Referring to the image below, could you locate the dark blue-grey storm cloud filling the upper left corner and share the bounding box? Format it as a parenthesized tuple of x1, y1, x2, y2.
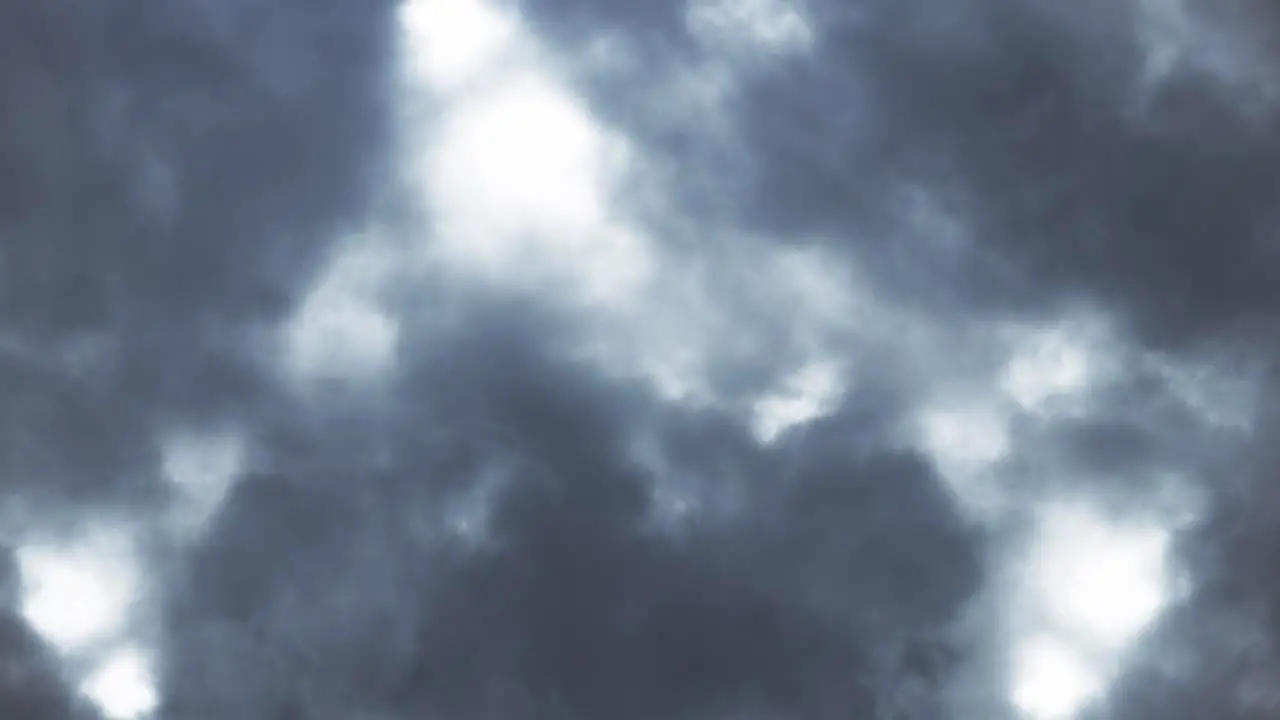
(0, 0, 390, 504)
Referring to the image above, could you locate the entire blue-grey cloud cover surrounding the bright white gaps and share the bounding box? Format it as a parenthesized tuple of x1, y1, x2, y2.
(0, 0, 1280, 719)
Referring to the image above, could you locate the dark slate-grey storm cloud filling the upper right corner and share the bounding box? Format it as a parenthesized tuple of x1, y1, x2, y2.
(522, 0, 1280, 346)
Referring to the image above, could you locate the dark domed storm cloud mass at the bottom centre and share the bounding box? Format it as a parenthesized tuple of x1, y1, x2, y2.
(166, 319, 979, 717)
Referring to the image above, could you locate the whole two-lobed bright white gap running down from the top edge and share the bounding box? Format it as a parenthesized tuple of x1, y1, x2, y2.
(391, 0, 652, 311)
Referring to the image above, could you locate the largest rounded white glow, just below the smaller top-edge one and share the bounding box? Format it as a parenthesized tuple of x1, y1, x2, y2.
(422, 70, 650, 304)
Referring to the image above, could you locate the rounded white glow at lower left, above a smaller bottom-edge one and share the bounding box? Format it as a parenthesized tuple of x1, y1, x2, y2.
(17, 529, 141, 653)
